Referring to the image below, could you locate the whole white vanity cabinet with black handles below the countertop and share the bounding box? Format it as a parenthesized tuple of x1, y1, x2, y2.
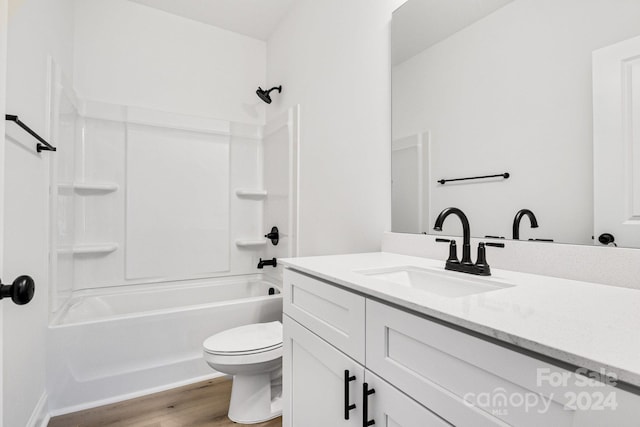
(283, 269, 640, 427)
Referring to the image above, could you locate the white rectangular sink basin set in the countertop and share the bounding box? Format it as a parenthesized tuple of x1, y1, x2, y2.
(356, 266, 515, 298)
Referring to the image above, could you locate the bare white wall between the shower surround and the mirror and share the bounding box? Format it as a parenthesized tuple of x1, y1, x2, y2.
(267, 0, 402, 256)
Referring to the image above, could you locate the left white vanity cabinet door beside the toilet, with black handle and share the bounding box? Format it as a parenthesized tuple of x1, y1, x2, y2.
(282, 315, 364, 427)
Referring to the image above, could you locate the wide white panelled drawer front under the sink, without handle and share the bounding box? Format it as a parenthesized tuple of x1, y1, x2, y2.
(366, 300, 638, 427)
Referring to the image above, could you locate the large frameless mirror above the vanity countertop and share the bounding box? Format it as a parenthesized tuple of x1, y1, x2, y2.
(391, 0, 640, 247)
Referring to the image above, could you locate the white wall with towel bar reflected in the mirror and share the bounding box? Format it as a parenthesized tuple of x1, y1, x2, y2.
(393, 0, 640, 244)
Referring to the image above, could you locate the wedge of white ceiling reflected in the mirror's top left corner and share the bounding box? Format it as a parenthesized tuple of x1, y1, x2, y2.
(391, 0, 513, 65)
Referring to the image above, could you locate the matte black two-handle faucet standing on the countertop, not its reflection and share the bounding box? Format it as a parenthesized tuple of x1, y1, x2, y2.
(433, 208, 504, 276)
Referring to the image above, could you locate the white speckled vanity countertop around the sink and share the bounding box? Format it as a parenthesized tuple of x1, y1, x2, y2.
(278, 252, 640, 387)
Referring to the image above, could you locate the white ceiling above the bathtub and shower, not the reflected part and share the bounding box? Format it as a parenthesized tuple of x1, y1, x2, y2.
(131, 0, 295, 40)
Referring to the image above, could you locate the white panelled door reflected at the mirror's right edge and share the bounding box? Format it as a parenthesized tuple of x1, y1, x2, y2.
(593, 33, 640, 247)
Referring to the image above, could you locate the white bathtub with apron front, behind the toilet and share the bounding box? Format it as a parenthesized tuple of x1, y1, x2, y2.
(47, 275, 282, 415)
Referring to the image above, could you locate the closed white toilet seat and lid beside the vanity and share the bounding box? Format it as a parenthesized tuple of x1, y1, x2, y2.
(202, 322, 282, 365)
